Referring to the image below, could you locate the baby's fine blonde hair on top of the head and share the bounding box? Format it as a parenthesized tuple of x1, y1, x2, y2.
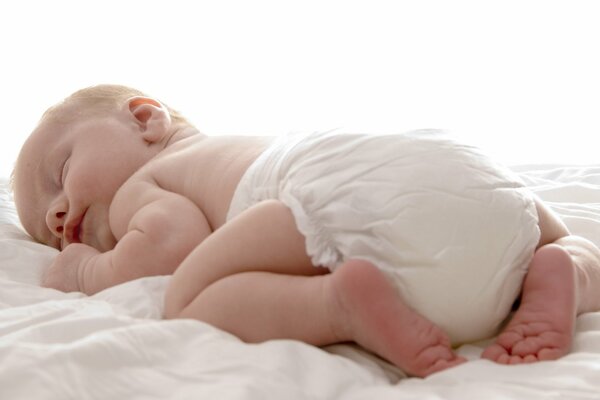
(42, 84, 192, 126)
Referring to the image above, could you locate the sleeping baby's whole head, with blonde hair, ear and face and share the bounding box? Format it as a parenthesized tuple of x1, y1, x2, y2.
(13, 85, 197, 251)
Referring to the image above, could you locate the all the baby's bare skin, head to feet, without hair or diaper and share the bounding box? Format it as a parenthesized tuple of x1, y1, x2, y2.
(15, 88, 600, 376)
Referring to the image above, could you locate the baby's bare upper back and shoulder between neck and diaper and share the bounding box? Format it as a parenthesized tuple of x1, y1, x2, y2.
(111, 134, 271, 234)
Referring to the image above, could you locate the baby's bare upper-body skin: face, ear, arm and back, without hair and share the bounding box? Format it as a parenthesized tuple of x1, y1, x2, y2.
(15, 102, 270, 294)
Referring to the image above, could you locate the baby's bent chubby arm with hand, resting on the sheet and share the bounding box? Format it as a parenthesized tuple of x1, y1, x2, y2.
(44, 190, 211, 294)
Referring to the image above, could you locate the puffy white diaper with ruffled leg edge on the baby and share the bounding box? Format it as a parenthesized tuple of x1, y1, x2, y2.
(227, 131, 540, 344)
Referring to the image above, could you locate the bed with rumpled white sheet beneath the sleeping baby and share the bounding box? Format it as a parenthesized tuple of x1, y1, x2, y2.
(0, 165, 600, 400)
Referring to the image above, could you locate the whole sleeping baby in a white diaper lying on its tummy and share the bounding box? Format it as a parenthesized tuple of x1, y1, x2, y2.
(13, 85, 600, 377)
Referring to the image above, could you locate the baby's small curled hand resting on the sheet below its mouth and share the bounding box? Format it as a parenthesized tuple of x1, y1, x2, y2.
(42, 243, 99, 292)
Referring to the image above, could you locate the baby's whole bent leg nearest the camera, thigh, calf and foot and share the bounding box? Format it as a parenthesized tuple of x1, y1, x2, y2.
(165, 201, 464, 376)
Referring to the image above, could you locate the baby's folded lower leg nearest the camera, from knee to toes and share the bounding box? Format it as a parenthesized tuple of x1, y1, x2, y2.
(178, 260, 465, 377)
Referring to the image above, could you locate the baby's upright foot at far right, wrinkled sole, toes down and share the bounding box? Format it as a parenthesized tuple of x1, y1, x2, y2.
(482, 244, 576, 364)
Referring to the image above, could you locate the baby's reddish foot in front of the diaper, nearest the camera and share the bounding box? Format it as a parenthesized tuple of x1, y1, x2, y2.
(331, 260, 466, 377)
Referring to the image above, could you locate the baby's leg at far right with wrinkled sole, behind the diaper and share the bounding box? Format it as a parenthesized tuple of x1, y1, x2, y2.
(482, 198, 600, 364)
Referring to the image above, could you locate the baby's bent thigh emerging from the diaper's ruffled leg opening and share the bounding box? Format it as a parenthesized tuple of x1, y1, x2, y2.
(165, 200, 316, 318)
